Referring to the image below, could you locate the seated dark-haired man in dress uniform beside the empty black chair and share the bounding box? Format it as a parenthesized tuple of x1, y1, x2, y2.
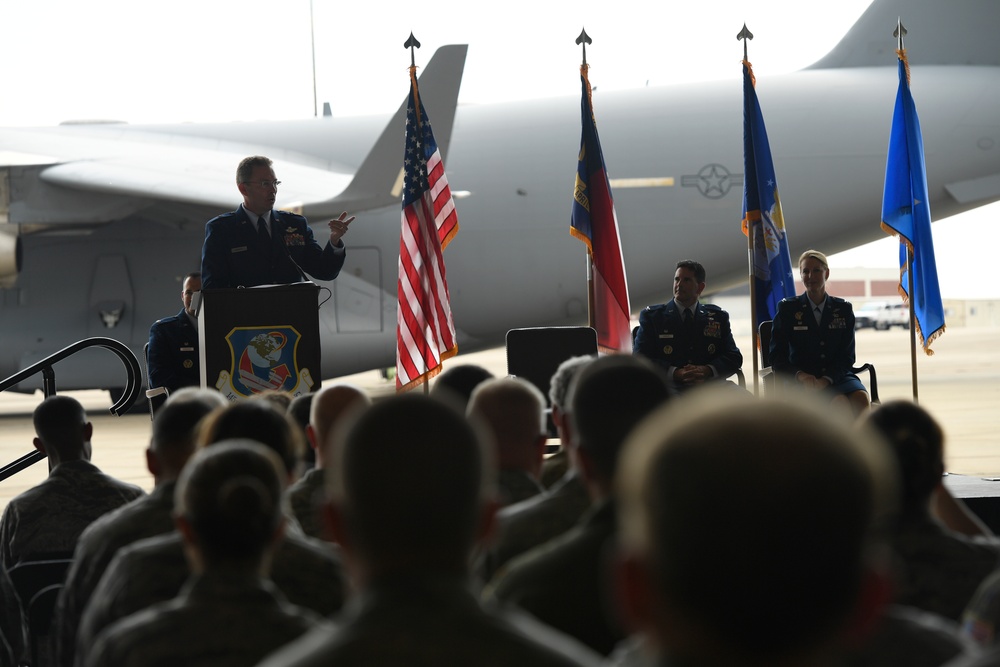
(632, 259, 743, 393)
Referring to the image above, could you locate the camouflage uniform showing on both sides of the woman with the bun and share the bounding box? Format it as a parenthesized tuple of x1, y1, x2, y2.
(77, 533, 345, 664)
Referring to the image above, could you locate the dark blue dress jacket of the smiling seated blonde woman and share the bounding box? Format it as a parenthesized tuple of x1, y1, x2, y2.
(770, 294, 864, 394)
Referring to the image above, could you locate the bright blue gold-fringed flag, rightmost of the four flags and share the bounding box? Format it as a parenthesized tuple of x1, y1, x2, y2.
(882, 55, 945, 354)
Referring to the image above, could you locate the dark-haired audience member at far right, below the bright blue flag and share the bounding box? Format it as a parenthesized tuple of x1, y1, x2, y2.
(867, 400, 1000, 621)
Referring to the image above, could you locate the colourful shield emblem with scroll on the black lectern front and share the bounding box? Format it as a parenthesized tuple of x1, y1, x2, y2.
(215, 326, 314, 400)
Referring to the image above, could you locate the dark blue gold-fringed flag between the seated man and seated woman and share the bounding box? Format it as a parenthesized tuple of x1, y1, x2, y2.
(743, 60, 795, 331)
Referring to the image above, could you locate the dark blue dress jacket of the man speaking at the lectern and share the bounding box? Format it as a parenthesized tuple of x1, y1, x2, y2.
(201, 206, 347, 289)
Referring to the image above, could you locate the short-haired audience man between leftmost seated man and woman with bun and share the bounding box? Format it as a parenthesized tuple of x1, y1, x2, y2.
(55, 388, 226, 665)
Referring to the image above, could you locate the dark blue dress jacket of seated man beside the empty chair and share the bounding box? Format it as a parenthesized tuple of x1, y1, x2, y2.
(633, 300, 743, 382)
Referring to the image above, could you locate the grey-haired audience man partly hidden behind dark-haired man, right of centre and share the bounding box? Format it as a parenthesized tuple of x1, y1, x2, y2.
(478, 356, 596, 582)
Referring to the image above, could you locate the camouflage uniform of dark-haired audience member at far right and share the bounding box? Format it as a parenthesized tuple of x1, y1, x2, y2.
(893, 517, 1000, 621)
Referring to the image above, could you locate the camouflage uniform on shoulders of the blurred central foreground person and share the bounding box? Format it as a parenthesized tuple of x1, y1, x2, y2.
(258, 575, 600, 667)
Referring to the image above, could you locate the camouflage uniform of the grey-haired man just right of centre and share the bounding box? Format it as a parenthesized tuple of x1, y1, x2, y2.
(479, 471, 590, 581)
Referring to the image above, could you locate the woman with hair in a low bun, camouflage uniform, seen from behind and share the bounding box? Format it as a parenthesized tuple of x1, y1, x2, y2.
(86, 440, 322, 667)
